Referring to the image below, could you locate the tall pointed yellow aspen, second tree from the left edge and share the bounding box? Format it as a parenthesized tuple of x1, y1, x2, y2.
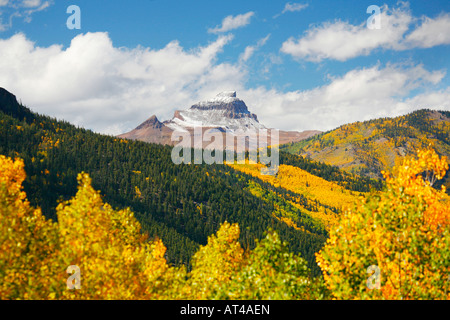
(57, 173, 183, 300)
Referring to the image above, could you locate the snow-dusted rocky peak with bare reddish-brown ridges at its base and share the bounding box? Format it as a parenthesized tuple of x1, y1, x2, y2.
(118, 91, 321, 148)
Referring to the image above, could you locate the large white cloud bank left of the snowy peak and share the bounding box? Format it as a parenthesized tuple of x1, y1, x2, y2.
(0, 33, 246, 134)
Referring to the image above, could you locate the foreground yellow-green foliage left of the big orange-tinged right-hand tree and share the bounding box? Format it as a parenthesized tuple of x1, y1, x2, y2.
(0, 156, 323, 299)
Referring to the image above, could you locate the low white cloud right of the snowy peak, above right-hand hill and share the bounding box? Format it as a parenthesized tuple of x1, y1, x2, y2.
(241, 65, 450, 131)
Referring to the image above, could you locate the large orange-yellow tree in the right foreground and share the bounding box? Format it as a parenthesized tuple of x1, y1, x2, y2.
(317, 149, 450, 299)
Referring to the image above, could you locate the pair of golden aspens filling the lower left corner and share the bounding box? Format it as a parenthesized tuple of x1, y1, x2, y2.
(0, 156, 185, 299)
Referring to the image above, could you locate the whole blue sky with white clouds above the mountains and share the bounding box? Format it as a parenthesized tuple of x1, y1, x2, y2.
(0, 0, 450, 134)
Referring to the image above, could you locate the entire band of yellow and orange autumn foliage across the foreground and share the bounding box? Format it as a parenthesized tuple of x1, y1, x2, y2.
(0, 149, 450, 299)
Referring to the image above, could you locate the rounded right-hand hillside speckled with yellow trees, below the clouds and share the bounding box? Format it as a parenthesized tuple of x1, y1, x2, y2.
(281, 109, 450, 189)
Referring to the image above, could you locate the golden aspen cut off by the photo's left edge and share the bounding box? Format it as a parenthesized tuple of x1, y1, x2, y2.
(0, 155, 63, 299)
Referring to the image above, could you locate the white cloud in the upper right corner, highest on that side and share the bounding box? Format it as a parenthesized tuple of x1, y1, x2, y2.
(281, 3, 450, 62)
